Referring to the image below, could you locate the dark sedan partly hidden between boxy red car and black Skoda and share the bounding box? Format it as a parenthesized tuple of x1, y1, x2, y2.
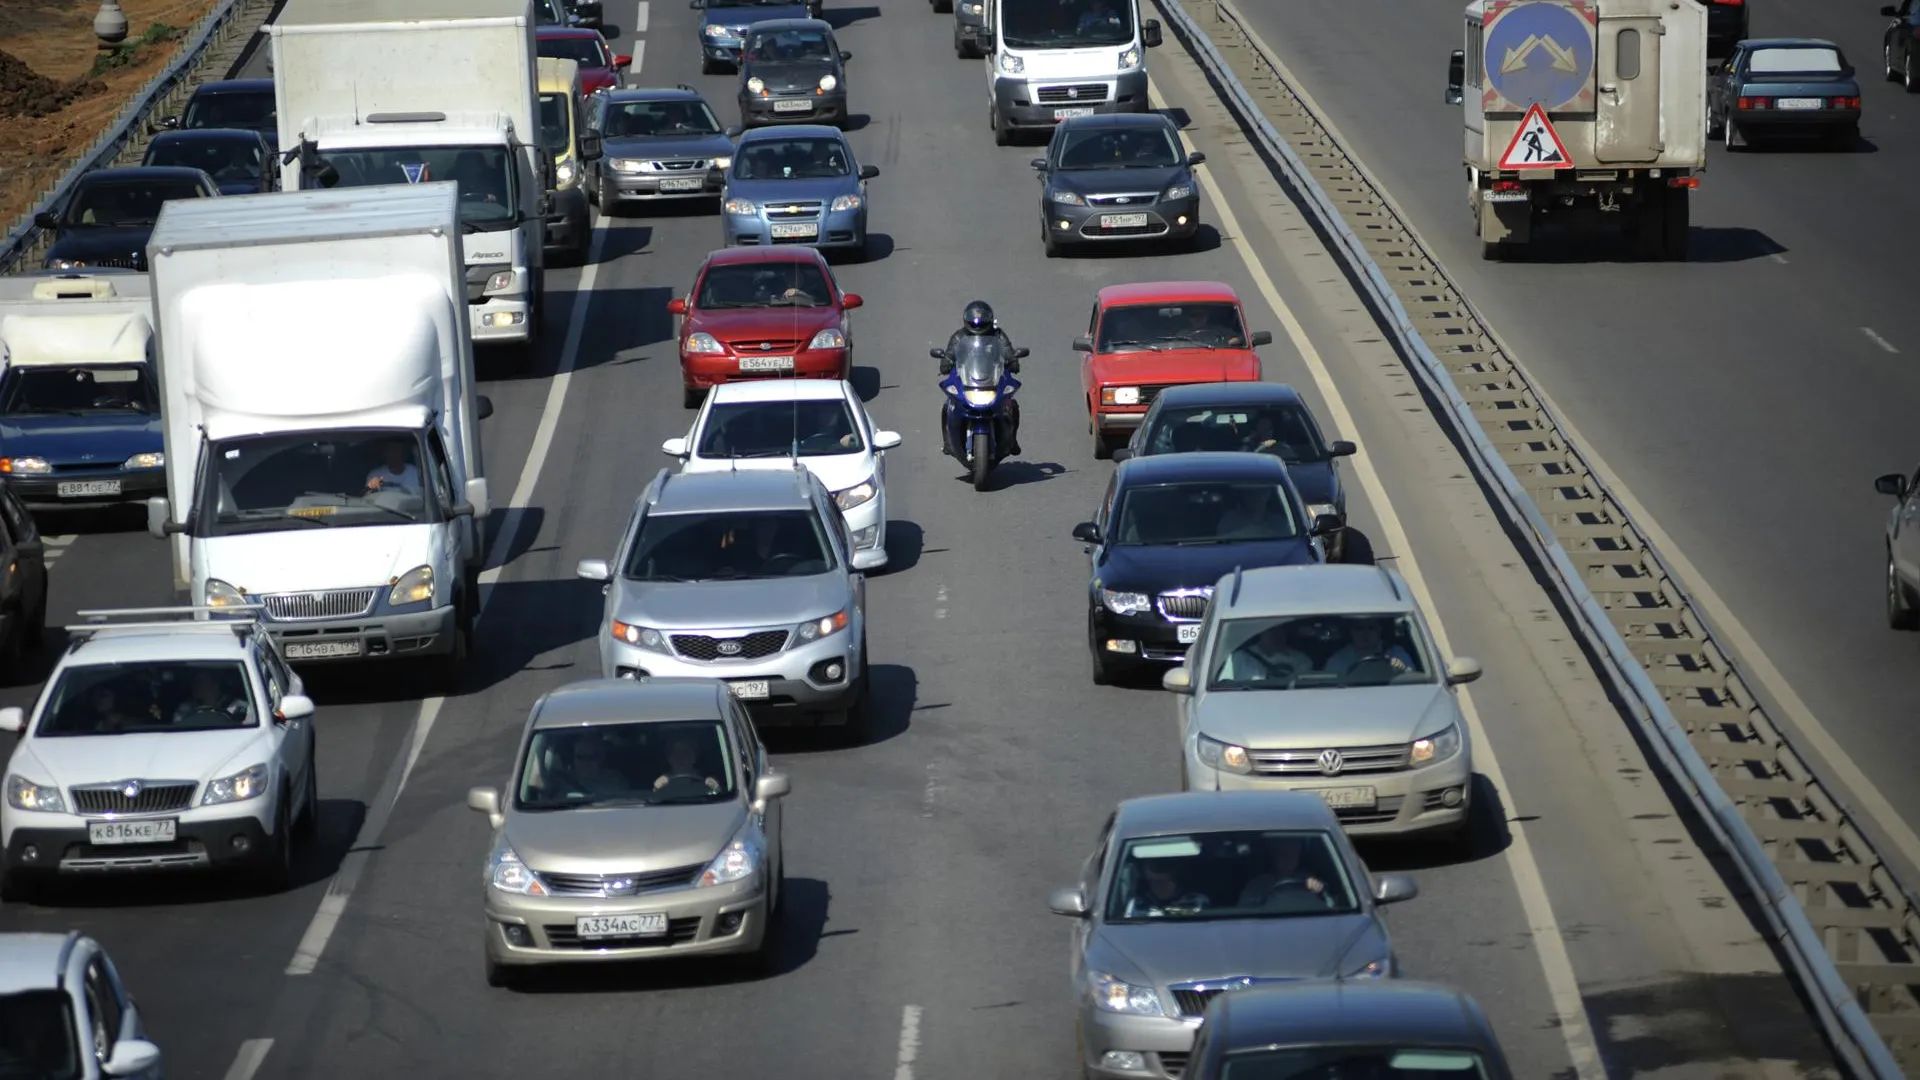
(1114, 382, 1357, 561)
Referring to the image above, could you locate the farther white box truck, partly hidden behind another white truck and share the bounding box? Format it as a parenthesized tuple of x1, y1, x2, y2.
(267, 0, 555, 365)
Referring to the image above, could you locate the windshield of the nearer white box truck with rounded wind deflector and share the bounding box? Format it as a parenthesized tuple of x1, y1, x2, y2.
(198, 429, 453, 536)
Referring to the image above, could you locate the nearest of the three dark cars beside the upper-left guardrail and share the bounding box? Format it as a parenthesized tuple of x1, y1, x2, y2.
(33, 165, 221, 271)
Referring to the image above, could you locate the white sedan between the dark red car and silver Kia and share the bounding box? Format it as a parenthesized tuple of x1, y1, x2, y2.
(660, 379, 900, 571)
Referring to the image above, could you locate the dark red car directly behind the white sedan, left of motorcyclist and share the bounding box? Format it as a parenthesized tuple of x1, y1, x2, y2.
(666, 246, 862, 409)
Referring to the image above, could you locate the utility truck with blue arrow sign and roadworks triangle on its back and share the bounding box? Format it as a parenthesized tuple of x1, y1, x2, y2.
(1446, 0, 1707, 261)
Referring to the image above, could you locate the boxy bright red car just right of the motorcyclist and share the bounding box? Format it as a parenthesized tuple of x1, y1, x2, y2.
(1073, 281, 1273, 461)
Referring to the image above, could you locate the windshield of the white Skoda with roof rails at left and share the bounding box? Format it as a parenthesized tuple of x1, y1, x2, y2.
(33, 659, 257, 738)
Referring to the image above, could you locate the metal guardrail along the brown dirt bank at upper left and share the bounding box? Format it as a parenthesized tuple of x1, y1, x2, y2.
(0, 0, 275, 273)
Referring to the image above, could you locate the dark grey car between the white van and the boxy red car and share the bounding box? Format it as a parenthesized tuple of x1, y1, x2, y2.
(1033, 113, 1206, 258)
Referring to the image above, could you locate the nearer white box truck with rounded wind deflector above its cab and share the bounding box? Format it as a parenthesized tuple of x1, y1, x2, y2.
(148, 183, 493, 678)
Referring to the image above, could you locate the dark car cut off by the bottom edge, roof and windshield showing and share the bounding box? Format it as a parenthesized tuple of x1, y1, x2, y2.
(1162, 978, 1513, 1080)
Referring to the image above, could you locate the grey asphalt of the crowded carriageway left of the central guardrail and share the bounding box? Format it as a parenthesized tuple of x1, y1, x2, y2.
(0, 0, 1843, 1080)
